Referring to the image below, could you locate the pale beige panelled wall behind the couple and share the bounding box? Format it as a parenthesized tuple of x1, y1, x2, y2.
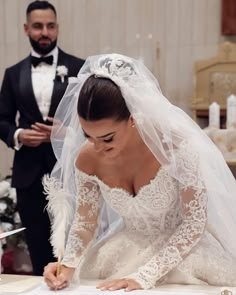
(0, 0, 235, 177)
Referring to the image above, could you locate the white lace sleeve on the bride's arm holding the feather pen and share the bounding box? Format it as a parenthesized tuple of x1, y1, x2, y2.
(62, 171, 102, 268)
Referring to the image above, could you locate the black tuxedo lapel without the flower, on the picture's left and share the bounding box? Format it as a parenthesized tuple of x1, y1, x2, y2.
(19, 57, 42, 121)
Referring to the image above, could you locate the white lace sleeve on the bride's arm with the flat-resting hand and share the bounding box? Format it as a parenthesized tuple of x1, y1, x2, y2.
(128, 142, 207, 289)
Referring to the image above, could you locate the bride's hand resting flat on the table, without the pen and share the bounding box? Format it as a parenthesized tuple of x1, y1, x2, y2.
(97, 279, 142, 291)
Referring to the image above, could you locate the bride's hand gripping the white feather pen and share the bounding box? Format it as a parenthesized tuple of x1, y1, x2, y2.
(43, 262, 75, 290)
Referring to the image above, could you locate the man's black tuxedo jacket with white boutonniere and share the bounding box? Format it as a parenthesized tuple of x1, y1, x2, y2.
(0, 49, 84, 189)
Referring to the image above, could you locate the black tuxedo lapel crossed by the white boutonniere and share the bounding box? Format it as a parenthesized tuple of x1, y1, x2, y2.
(48, 49, 69, 117)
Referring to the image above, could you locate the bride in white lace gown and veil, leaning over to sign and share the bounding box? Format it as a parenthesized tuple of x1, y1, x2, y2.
(44, 54, 236, 291)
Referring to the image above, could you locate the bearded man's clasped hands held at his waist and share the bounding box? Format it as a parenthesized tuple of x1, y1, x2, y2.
(18, 129, 48, 147)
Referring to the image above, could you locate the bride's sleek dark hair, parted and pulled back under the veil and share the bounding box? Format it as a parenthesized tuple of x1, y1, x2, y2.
(77, 75, 130, 121)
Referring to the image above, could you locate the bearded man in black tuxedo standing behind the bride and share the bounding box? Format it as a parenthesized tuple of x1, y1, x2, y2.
(0, 1, 84, 275)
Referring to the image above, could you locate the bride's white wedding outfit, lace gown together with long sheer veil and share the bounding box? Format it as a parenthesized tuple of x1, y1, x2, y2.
(44, 54, 236, 289)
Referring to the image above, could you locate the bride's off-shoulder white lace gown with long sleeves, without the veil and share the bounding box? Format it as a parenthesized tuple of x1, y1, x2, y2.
(63, 167, 236, 289)
